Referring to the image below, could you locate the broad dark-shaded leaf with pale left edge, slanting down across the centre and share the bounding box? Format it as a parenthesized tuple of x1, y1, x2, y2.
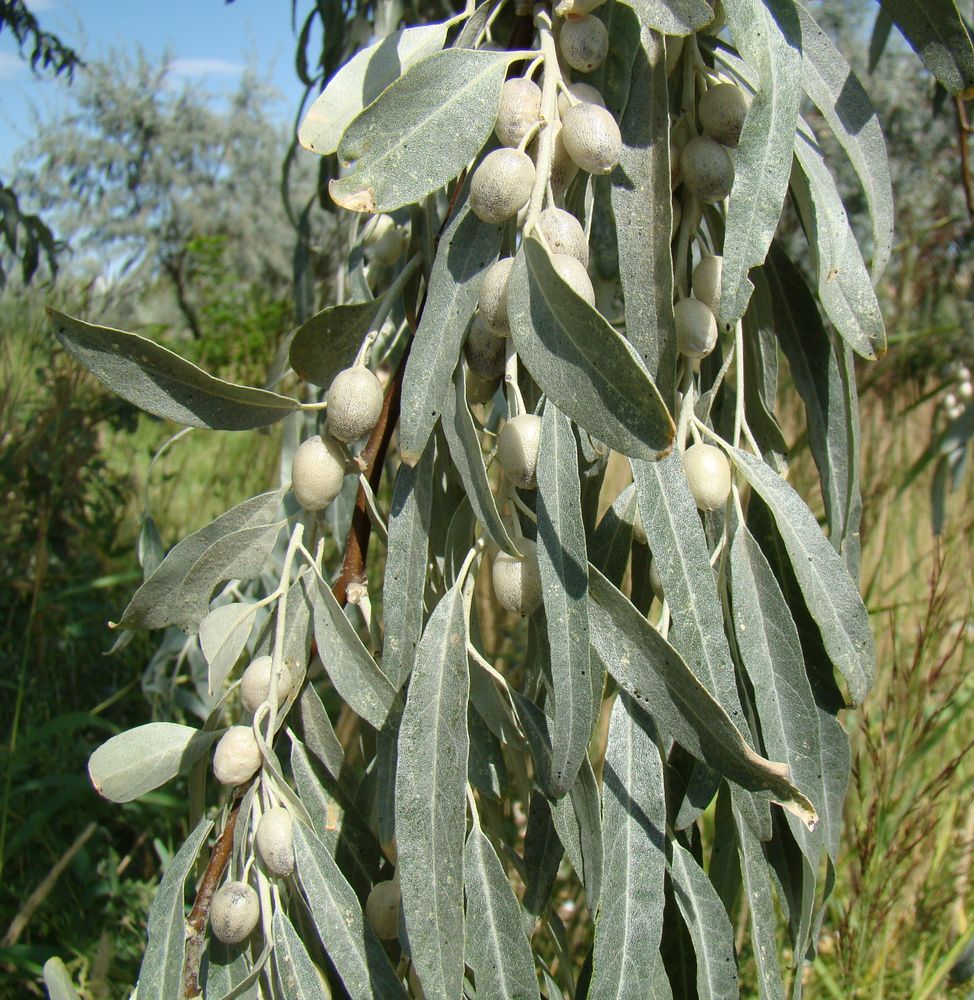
(508, 239, 675, 461)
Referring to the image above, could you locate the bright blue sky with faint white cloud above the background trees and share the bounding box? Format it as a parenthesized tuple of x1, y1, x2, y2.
(0, 0, 307, 171)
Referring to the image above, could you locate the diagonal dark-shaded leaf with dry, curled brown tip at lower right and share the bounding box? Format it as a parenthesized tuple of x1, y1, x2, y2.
(589, 566, 816, 825)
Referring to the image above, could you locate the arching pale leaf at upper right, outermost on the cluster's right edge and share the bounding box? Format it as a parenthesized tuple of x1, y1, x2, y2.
(795, 4, 893, 281)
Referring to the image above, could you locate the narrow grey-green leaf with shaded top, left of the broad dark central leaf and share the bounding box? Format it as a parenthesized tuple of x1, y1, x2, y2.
(399, 202, 501, 465)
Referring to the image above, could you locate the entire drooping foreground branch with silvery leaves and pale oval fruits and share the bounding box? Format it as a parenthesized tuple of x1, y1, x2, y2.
(38, 0, 974, 1000)
